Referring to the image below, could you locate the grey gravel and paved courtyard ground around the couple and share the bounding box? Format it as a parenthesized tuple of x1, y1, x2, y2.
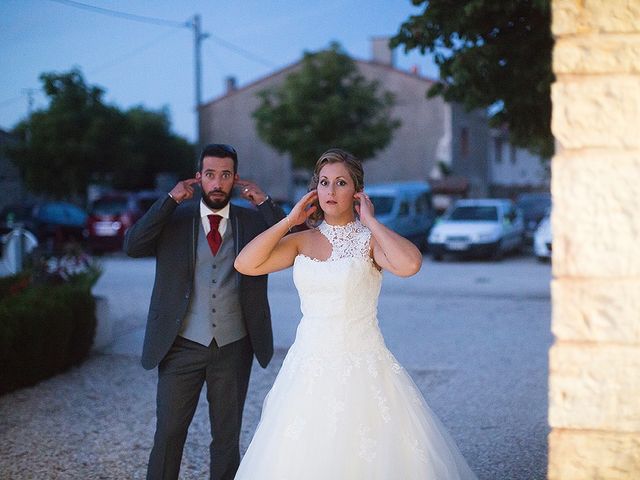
(0, 255, 552, 480)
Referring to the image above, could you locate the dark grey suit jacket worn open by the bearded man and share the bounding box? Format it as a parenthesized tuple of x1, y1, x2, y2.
(124, 195, 284, 369)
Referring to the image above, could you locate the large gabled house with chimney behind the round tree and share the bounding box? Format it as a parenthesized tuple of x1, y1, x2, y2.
(200, 38, 539, 200)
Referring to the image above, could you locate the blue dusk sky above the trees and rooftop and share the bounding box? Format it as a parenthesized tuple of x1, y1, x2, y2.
(0, 0, 437, 141)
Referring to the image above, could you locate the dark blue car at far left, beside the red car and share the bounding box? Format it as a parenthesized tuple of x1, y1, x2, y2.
(0, 202, 87, 250)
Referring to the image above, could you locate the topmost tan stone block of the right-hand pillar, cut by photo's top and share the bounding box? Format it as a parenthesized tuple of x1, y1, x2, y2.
(551, 0, 640, 36)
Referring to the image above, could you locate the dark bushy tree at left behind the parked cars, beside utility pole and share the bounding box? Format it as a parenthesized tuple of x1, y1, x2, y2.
(8, 69, 193, 199)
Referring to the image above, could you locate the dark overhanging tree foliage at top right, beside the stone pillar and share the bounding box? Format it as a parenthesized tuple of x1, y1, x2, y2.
(391, 0, 554, 158)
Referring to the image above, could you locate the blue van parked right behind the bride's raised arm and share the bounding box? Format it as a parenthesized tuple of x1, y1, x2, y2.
(365, 182, 435, 250)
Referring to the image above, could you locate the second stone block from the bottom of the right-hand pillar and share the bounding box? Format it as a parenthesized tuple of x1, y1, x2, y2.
(549, 344, 640, 433)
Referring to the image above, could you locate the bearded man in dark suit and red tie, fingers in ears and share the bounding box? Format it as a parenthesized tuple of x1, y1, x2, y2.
(124, 144, 284, 480)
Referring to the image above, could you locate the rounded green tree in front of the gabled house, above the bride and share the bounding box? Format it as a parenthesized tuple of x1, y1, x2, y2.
(253, 43, 400, 168)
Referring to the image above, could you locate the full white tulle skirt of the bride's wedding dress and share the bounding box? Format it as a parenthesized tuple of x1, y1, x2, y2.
(235, 330, 476, 480)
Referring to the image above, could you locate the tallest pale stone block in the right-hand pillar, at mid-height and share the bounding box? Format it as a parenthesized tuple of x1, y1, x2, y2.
(551, 150, 640, 279)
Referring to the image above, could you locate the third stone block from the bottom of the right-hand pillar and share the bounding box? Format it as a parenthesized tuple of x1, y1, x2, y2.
(551, 278, 640, 344)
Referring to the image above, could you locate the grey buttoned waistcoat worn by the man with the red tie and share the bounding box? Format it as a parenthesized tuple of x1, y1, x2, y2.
(180, 221, 247, 347)
